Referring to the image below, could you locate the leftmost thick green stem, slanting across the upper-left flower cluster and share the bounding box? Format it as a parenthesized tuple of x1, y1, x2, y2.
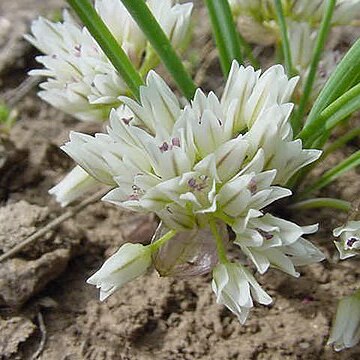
(67, 0, 143, 99)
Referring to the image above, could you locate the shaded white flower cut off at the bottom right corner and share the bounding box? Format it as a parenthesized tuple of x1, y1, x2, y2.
(328, 291, 360, 351)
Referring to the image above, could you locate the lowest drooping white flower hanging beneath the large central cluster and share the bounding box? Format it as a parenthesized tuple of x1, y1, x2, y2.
(212, 263, 272, 324)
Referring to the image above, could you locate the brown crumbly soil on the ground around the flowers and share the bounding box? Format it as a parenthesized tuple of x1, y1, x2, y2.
(0, 0, 360, 360)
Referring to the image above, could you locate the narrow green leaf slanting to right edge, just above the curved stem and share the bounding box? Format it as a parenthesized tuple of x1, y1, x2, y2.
(299, 150, 360, 198)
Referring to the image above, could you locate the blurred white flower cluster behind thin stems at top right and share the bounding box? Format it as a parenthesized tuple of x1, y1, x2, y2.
(230, 0, 360, 96)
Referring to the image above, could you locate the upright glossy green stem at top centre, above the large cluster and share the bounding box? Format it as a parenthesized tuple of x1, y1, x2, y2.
(205, 0, 242, 76)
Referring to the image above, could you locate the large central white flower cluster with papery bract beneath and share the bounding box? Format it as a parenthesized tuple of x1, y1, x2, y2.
(62, 62, 324, 322)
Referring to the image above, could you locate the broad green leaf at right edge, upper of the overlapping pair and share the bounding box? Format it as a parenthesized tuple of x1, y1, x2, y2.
(298, 39, 360, 145)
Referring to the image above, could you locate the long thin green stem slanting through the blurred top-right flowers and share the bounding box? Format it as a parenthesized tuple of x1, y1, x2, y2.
(293, 0, 336, 134)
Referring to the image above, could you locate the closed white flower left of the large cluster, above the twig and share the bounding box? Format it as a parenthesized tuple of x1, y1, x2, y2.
(49, 166, 101, 206)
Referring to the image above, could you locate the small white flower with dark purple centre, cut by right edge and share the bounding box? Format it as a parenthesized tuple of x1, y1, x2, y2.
(333, 220, 360, 260)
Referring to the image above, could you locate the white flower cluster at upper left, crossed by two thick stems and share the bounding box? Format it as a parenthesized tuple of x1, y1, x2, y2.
(25, 0, 192, 122)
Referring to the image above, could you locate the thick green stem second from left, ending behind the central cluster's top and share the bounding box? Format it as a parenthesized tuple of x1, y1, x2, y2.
(119, 0, 196, 100)
